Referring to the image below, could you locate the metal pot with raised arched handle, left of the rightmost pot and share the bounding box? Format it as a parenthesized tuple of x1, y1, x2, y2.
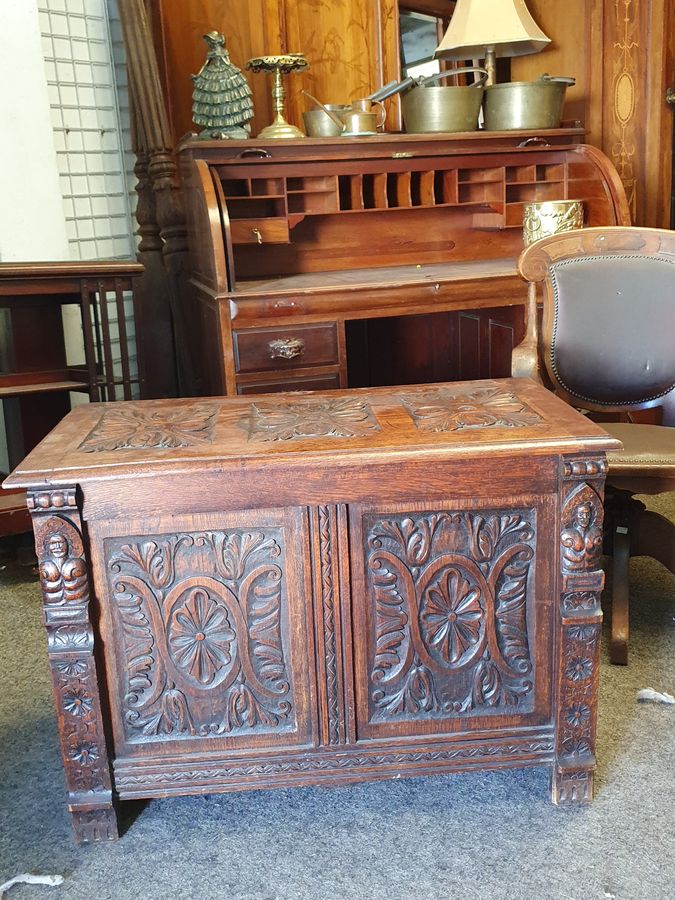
(402, 68, 487, 134)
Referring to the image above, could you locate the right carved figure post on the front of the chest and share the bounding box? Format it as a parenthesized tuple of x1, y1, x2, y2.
(552, 456, 607, 804)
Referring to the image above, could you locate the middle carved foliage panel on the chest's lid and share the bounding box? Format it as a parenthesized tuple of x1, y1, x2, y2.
(241, 397, 380, 441)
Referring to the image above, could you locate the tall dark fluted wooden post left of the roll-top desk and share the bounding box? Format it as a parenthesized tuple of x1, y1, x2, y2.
(119, 0, 196, 396)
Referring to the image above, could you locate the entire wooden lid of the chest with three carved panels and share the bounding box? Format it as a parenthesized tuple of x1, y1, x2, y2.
(5, 379, 620, 489)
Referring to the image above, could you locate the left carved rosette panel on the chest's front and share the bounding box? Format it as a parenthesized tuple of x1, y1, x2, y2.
(105, 528, 295, 742)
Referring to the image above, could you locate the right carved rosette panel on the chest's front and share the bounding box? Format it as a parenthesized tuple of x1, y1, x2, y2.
(364, 509, 536, 722)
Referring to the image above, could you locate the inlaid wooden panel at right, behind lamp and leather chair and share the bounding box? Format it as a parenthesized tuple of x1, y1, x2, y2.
(511, 0, 675, 228)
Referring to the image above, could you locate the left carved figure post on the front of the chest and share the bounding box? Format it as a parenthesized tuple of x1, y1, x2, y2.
(28, 487, 117, 842)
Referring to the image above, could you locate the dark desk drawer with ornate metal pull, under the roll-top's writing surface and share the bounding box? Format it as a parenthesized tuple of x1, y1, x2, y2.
(233, 322, 338, 373)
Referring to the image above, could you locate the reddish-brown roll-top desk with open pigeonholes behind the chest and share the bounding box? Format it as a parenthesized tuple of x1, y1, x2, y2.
(179, 129, 628, 394)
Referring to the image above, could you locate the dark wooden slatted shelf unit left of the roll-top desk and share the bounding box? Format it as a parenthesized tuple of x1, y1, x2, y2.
(0, 260, 143, 535)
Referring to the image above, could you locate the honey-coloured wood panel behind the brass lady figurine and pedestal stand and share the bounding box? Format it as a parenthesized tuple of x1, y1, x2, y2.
(149, 0, 400, 141)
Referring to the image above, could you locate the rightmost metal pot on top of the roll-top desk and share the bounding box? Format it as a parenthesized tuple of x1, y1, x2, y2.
(484, 75, 575, 131)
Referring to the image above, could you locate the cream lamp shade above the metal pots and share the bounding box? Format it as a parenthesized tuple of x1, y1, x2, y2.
(435, 0, 551, 59)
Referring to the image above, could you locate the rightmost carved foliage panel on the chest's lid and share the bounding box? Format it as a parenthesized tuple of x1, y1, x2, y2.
(401, 386, 542, 432)
